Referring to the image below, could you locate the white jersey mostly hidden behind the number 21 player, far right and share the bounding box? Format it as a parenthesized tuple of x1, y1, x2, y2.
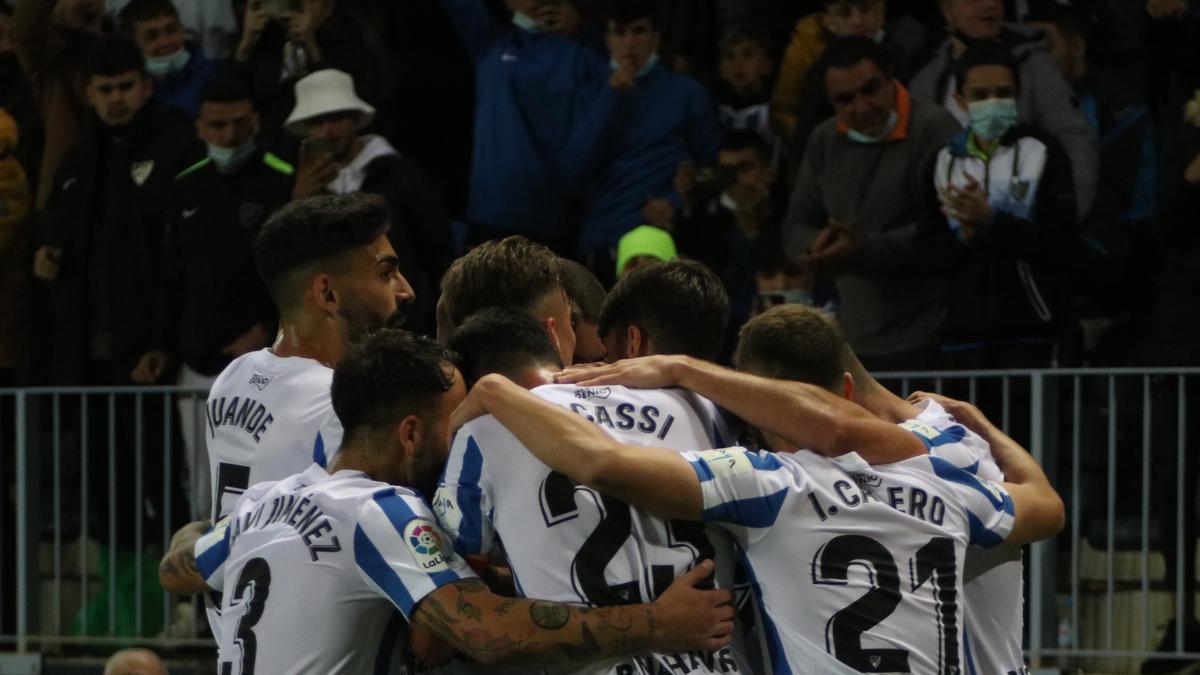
(900, 399, 1026, 675)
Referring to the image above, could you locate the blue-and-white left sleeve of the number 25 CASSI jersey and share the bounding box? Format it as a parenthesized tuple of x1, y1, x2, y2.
(433, 425, 496, 555)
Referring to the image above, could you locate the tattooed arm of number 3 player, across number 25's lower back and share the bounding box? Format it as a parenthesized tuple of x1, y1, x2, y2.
(413, 561, 733, 664)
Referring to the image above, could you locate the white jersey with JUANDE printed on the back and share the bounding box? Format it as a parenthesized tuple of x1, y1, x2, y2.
(204, 350, 342, 521)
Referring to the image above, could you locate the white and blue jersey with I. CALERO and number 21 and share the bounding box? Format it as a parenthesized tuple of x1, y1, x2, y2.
(684, 448, 1013, 675)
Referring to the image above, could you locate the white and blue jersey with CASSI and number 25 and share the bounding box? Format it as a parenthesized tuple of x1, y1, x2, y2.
(433, 384, 745, 675)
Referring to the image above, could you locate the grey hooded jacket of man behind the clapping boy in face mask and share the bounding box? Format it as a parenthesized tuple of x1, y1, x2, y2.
(908, 24, 1100, 217)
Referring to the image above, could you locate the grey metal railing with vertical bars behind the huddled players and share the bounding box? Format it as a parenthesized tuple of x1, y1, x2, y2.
(0, 369, 1200, 673)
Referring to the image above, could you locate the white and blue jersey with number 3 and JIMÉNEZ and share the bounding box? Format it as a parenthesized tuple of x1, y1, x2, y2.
(196, 465, 474, 675)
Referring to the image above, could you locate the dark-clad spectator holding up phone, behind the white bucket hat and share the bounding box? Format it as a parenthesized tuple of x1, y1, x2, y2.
(230, 0, 385, 151)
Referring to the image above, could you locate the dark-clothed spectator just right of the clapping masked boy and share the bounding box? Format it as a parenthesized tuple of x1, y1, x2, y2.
(1032, 5, 1160, 355)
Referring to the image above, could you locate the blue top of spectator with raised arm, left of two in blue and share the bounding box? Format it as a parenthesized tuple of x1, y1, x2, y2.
(442, 0, 610, 238)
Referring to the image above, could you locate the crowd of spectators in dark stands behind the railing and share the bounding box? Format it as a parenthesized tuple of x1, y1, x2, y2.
(0, 0, 1200, 386)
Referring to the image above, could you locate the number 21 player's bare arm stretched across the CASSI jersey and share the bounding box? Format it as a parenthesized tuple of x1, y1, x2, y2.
(452, 375, 703, 520)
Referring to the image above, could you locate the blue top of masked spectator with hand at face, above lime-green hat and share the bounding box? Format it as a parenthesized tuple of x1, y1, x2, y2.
(566, 64, 720, 253)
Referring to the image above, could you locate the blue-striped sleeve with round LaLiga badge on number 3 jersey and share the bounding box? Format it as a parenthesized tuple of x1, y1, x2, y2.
(354, 488, 475, 619)
